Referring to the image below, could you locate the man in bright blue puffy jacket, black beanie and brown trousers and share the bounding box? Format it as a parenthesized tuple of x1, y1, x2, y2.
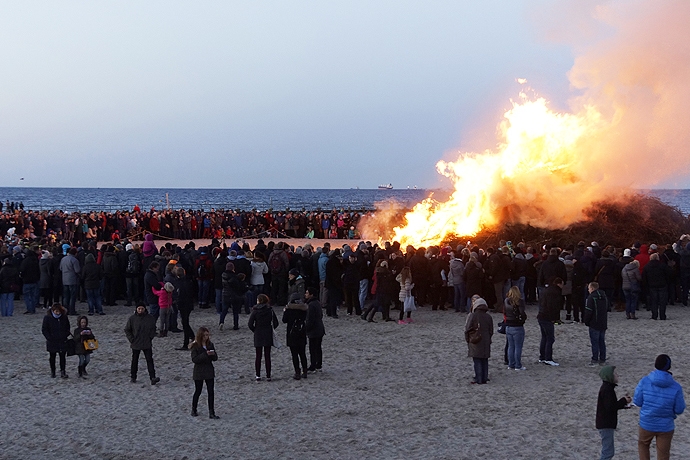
(633, 355, 685, 460)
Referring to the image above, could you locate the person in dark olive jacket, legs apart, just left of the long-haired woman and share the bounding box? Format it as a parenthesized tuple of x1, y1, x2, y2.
(125, 302, 161, 385)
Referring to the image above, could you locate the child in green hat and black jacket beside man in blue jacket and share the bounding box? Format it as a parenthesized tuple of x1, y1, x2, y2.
(596, 366, 632, 460)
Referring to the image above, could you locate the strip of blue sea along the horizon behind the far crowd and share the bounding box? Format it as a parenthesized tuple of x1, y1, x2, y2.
(0, 187, 690, 215)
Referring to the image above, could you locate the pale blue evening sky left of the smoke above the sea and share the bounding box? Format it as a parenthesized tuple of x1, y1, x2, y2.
(0, 0, 676, 188)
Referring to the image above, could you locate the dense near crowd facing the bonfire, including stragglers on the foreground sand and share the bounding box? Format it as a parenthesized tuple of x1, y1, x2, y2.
(5, 223, 690, 458)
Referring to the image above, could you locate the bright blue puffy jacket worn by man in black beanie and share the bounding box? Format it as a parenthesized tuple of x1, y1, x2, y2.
(633, 369, 685, 433)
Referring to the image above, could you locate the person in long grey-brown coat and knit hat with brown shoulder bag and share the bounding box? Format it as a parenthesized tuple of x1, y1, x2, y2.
(465, 297, 494, 385)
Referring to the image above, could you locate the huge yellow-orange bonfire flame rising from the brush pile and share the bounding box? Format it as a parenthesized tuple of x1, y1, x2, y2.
(393, 93, 604, 247)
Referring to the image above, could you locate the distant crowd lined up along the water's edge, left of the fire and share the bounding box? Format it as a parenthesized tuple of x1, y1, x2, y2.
(0, 202, 372, 245)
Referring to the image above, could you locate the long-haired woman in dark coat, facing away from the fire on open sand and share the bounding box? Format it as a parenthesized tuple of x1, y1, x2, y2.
(190, 327, 220, 420)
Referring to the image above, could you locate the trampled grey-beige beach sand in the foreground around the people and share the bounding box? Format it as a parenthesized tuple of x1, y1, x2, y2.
(0, 244, 690, 459)
